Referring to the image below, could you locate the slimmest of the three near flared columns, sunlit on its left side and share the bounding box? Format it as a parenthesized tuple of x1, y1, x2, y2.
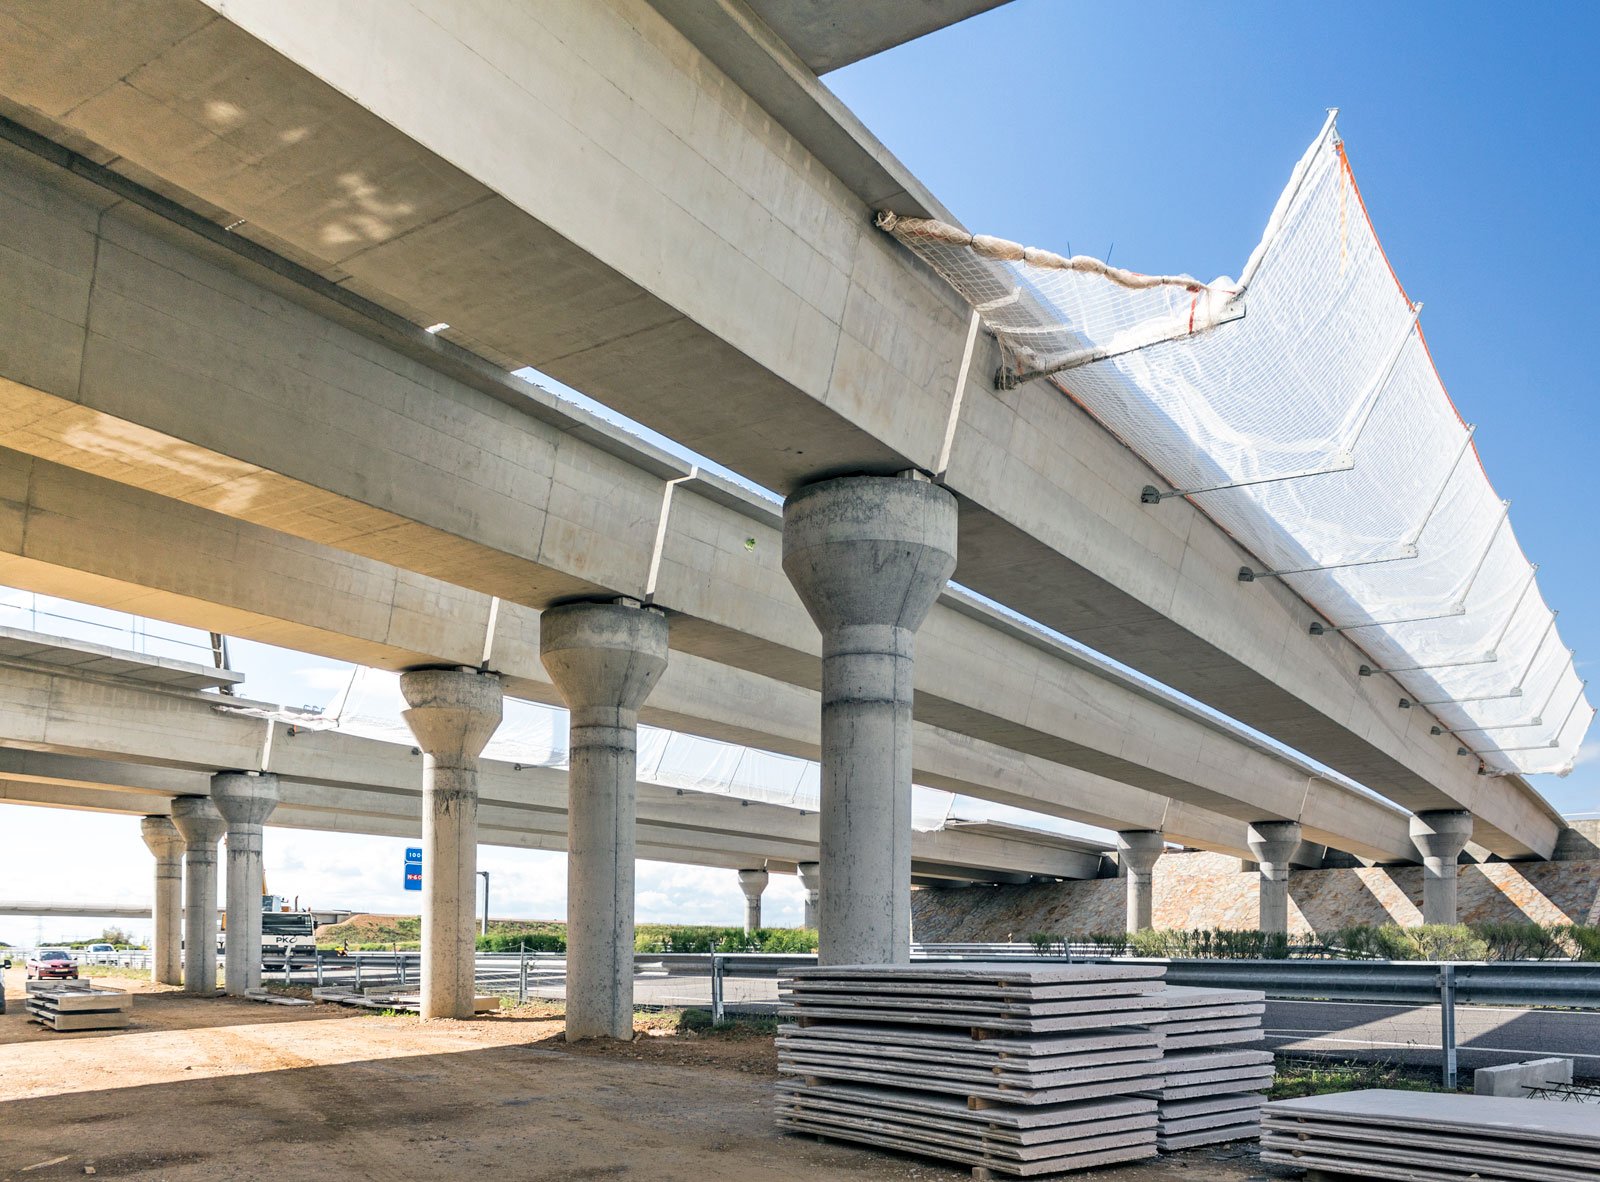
(400, 669, 502, 1017)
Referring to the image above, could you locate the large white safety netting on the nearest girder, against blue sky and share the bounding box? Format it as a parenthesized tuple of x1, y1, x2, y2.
(880, 117, 1592, 774)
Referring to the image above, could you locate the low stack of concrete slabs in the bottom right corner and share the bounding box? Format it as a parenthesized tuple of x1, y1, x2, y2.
(1261, 1089, 1600, 1182)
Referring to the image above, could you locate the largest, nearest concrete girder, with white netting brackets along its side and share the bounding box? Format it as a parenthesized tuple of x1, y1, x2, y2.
(8, 0, 1557, 856)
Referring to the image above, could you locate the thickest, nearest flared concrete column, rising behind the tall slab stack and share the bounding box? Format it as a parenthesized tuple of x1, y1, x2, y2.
(784, 473, 955, 964)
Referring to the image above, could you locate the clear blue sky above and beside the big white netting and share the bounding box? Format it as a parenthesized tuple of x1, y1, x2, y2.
(826, 0, 1600, 813)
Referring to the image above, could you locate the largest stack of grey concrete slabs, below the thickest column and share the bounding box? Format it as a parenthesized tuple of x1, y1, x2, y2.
(778, 963, 1166, 1177)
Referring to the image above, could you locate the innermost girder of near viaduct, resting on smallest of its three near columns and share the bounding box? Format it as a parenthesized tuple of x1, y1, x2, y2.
(0, 449, 1376, 857)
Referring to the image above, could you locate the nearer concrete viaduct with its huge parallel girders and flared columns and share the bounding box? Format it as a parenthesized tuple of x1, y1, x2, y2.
(0, 0, 1562, 1036)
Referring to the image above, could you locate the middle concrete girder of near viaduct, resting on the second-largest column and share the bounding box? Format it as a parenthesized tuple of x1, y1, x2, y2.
(0, 173, 1403, 856)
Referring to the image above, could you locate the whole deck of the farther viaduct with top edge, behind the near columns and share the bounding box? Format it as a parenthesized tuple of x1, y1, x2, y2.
(0, 633, 1101, 881)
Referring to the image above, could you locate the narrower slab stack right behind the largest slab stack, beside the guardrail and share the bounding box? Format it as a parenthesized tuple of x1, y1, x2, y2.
(1149, 985, 1274, 1153)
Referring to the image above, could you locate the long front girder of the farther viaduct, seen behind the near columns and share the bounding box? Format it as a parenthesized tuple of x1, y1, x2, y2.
(0, 664, 1099, 878)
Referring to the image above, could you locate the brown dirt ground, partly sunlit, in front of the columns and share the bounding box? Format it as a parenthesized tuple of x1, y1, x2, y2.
(0, 969, 1280, 1182)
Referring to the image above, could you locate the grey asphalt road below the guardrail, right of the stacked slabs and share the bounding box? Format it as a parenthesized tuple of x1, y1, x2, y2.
(1264, 1001, 1600, 1078)
